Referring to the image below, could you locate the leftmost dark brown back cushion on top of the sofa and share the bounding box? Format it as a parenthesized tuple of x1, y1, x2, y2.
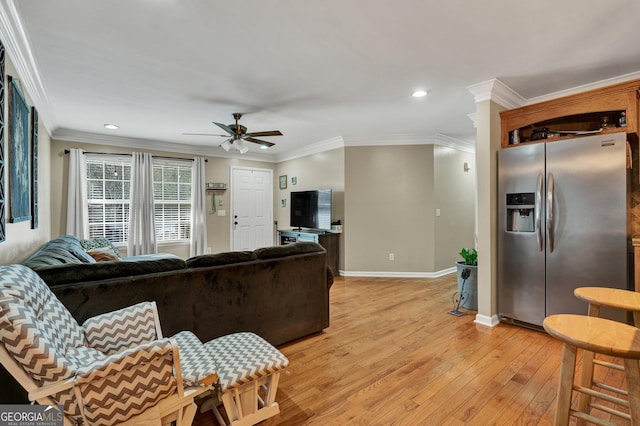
(36, 256, 187, 286)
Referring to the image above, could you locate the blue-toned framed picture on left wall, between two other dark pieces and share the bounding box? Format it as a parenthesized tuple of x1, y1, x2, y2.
(8, 76, 31, 223)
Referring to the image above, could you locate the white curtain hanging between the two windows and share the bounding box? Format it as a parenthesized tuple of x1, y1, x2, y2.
(127, 152, 156, 256)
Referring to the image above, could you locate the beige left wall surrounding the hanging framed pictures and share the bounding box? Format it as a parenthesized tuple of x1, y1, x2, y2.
(0, 54, 51, 265)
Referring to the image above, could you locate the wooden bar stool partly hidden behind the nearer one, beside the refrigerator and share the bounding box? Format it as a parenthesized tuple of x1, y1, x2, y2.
(573, 287, 640, 425)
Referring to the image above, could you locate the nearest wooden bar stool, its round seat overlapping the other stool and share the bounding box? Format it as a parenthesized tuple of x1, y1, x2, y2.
(542, 314, 640, 426)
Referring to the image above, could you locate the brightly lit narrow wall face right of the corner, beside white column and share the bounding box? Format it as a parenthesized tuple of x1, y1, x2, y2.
(433, 145, 476, 271)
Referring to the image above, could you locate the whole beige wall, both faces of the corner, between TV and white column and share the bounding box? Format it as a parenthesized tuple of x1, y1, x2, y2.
(344, 145, 475, 275)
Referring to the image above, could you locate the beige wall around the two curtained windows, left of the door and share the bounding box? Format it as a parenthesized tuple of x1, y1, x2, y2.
(51, 140, 275, 258)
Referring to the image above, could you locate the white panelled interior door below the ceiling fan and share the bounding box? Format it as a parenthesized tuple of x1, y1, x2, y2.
(231, 167, 273, 251)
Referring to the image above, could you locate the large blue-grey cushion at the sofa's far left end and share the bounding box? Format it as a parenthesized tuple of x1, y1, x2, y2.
(22, 235, 95, 270)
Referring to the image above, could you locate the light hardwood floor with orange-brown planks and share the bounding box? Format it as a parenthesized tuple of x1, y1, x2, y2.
(195, 274, 624, 426)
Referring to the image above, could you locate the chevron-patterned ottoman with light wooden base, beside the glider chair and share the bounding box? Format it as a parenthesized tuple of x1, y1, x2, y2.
(201, 332, 289, 426)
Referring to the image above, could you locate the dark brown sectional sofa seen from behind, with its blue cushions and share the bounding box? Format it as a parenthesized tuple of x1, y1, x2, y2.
(24, 236, 333, 345)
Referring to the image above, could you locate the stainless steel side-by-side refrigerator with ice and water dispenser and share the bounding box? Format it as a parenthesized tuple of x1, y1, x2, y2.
(498, 132, 629, 326)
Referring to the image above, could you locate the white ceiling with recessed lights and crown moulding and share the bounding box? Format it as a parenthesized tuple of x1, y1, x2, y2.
(0, 0, 640, 158)
